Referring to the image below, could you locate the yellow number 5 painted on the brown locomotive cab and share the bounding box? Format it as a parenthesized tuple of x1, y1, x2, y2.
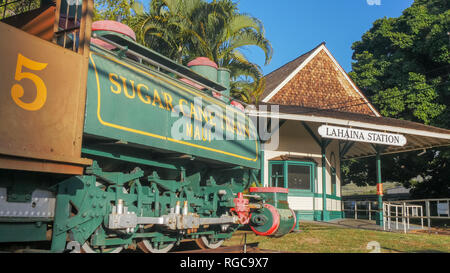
(11, 53, 48, 111)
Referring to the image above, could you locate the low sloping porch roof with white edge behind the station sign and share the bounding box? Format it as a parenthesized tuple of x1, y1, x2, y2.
(247, 104, 450, 159)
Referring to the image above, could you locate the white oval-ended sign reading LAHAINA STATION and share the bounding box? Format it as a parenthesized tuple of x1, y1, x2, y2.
(318, 125, 406, 146)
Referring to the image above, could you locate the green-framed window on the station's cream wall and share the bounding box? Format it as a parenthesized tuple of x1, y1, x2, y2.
(269, 161, 316, 192)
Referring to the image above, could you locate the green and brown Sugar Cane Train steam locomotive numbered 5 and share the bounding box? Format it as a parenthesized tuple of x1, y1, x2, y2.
(0, 0, 296, 253)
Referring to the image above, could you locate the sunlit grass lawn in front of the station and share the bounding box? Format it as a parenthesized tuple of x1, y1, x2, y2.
(224, 222, 450, 253)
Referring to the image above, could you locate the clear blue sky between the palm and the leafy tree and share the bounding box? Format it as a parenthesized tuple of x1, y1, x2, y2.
(238, 0, 413, 75)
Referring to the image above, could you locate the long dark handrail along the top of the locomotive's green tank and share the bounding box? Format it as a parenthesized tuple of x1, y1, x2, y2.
(92, 33, 249, 106)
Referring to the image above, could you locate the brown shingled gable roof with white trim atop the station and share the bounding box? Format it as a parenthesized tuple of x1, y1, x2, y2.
(262, 43, 381, 117)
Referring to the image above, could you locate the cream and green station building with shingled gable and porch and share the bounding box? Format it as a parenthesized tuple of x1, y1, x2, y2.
(249, 43, 450, 224)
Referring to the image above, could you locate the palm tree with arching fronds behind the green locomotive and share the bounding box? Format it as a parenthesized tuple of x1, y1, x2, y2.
(133, 0, 272, 103)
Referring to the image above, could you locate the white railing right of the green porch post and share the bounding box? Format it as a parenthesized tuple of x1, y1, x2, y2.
(383, 198, 450, 233)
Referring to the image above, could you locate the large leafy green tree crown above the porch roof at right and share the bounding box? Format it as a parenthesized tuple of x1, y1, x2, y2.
(349, 0, 450, 127)
